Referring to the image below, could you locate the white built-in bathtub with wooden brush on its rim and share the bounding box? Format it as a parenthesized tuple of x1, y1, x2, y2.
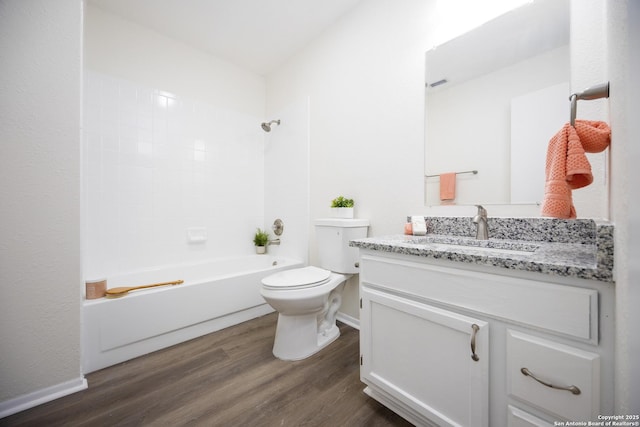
(82, 255, 303, 373)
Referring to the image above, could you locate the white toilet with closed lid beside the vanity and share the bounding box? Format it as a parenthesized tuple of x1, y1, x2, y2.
(260, 218, 369, 360)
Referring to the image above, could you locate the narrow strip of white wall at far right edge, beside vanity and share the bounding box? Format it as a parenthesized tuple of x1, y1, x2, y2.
(604, 0, 640, 414)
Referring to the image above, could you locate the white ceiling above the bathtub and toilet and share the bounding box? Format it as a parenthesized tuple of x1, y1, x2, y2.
(88, 0, 361, 75)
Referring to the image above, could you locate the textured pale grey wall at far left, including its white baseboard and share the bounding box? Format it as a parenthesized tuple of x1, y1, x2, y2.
(0, 0, 86, 417)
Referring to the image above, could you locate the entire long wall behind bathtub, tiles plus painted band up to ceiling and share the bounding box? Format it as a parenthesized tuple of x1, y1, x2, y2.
(84, 5, 265, 278)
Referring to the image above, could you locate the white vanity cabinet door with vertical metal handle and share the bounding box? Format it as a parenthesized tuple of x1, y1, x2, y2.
(360, 286, 489, 427)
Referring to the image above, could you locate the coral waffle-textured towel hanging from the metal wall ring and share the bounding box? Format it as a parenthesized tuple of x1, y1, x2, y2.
(542, 120, 611, 218)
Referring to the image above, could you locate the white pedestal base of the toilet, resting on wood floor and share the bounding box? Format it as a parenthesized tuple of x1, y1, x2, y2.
(273, 313, 340, 360)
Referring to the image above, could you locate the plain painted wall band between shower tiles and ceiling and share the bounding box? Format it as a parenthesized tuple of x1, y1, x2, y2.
(84, 3, 265, 117)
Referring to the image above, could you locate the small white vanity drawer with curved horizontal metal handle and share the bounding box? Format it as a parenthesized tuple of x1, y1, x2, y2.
(507, 330, 600, 420)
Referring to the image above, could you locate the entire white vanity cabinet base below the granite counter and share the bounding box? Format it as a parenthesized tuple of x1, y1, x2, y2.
(360, 250, 613, 427)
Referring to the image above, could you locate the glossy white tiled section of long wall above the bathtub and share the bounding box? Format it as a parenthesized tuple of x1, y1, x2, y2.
(83, 70, 265, 278)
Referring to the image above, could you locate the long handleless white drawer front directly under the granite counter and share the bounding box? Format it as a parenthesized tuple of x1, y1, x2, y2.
(360, 253, 598, 344)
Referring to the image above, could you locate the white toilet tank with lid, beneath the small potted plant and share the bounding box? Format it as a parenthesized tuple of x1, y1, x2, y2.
(315, 218, 369, 274)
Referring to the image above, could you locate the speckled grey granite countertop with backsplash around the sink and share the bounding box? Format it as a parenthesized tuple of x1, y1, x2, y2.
(350, 217, 613, 282)
